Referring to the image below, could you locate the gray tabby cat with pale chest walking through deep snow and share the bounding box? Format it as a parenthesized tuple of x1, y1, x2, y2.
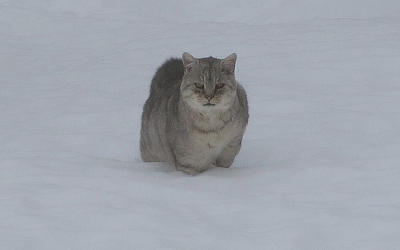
(140, 52, 249, 175)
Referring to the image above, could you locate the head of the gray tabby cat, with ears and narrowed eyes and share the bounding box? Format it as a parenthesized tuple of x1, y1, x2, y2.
(181, 52, 237, 110)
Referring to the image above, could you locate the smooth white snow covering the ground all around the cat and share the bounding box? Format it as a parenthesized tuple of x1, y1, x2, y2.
(0, 0, 400, 250)
